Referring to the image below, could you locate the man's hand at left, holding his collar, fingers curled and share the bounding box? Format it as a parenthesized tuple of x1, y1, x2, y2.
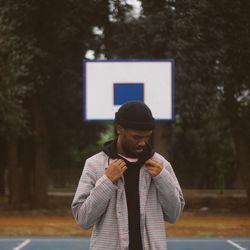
(105, 159, 127, 183)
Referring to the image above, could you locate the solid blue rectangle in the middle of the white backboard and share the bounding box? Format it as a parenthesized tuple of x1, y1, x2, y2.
(114, 83, 144, 105)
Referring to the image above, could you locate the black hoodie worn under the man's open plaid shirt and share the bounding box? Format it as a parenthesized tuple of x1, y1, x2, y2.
(103, 140, 154, 250)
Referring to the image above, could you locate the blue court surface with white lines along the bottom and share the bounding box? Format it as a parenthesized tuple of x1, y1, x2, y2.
(0, 237, 250, 250)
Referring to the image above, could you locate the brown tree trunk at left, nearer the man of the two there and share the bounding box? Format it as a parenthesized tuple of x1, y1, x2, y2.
(32, 94, 48, 208)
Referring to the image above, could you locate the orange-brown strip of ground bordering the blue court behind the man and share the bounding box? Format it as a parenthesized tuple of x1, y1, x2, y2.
(0, 212, 250, 237)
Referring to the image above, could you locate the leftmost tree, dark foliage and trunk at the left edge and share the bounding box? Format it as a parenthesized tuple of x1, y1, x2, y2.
(0, 1, 40, 207)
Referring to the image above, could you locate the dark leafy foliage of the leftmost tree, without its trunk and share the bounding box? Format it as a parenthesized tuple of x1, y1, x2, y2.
(0, 1, 39, 135)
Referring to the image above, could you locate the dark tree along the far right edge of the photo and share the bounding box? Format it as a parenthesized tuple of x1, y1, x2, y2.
(209, 0, 250, 206)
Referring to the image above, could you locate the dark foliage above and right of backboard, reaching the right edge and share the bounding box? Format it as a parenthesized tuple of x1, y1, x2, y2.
(101, 0, 250, 188)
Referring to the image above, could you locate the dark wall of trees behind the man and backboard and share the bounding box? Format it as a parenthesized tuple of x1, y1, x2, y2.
(0, 0, 250, 209)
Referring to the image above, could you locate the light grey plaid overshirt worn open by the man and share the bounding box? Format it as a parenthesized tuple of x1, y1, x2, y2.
(72, 152, 185, 250)
